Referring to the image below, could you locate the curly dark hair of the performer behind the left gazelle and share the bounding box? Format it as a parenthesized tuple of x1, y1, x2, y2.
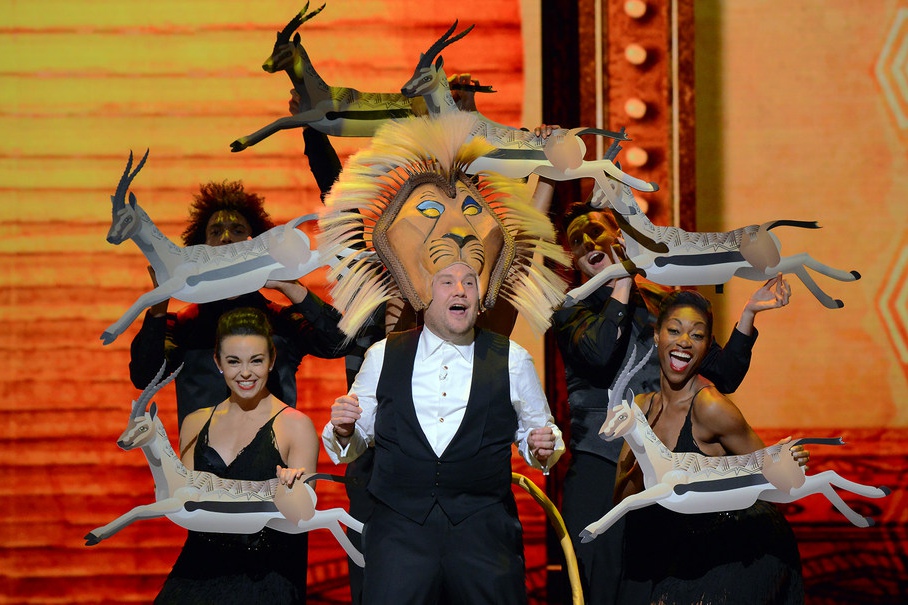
(183, 181, 274, 246)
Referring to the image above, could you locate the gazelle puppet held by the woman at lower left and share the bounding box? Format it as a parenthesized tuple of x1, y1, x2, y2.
(85, 364, 364, 567)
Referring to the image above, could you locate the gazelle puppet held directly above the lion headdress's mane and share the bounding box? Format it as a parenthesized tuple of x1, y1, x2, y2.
(401, 21, 658, 198)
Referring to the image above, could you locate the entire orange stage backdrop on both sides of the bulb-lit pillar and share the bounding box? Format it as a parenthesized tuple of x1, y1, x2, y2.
(0, 0, 908, 603)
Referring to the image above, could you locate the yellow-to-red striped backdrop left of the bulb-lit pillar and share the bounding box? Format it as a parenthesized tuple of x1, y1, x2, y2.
(0, 0, 544, 603)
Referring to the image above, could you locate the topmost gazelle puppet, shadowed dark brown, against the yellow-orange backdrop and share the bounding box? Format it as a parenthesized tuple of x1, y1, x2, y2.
(230, 2, 415, 152)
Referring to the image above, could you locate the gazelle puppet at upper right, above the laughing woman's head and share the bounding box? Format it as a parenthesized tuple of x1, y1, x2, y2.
(564, 142, 861, 309)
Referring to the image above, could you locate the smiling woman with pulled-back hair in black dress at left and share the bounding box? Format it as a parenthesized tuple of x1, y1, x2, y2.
(155, 308, 319, 605)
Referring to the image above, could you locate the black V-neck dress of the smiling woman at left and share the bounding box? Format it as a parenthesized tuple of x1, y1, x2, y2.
(155, 408, 308, 605)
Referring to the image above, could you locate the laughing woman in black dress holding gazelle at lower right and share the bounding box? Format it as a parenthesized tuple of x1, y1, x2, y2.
(615, 291, 808, 605)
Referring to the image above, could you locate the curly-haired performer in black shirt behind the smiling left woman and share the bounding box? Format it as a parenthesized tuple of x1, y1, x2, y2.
(129, 181, 347, 426)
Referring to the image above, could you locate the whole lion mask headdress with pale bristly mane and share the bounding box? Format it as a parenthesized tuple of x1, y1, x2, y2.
(319, 112, 569, 338)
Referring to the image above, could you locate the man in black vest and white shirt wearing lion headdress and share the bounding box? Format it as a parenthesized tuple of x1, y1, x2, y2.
(320, 114, 566, 604)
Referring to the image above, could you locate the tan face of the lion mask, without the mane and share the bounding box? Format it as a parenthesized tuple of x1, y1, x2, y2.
(373, 173, 514, 310)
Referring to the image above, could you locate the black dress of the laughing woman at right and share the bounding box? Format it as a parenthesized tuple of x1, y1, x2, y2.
(618, 396, 804, 605)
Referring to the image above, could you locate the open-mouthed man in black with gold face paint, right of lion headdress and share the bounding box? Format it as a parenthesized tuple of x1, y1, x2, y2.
(552, 203, 790, 603)
